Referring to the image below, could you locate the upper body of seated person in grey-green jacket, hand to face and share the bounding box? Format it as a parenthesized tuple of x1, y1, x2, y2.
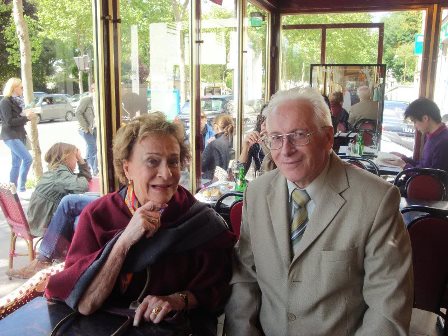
(27, 142, 92, 237)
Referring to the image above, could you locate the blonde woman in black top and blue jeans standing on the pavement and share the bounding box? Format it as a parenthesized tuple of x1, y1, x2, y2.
(0, 78, 34, 193)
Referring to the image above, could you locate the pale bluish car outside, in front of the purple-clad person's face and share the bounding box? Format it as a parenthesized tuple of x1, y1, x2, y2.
(383, 100, 415, 137)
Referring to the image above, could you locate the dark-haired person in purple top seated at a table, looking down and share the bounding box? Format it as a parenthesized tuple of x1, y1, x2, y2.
(388, 98, 448, 172)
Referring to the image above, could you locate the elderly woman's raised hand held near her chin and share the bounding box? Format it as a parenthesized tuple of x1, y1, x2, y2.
(120, 201, 167, 248)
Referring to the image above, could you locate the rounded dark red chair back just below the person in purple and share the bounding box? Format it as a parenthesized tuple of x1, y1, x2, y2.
(394, 167, 448, 201)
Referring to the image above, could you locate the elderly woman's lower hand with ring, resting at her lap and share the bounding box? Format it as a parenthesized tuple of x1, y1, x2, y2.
(134, 293, 187, 326)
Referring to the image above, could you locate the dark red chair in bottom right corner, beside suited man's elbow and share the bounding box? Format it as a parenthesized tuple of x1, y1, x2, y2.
(401, 205, 448, 335)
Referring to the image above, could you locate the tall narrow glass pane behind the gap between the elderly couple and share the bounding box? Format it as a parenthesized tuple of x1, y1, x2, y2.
(200, 1, 238, 183)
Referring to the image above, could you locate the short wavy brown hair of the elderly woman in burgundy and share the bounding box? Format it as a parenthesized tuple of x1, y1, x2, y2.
(112, 112, 190, 184)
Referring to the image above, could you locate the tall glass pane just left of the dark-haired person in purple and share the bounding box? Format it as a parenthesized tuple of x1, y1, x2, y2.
(377, 11, 425, 156)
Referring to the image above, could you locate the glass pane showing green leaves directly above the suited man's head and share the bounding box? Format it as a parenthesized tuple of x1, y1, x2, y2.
(280, 29, 321, 90)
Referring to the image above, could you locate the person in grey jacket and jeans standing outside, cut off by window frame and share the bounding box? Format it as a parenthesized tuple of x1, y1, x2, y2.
(76, 84, 98, 176)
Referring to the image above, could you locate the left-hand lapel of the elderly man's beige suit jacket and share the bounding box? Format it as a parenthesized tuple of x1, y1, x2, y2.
(266, 173, 291, 267)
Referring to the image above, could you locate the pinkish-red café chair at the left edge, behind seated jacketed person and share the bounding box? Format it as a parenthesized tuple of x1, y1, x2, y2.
(0, 183, 42, 280)
